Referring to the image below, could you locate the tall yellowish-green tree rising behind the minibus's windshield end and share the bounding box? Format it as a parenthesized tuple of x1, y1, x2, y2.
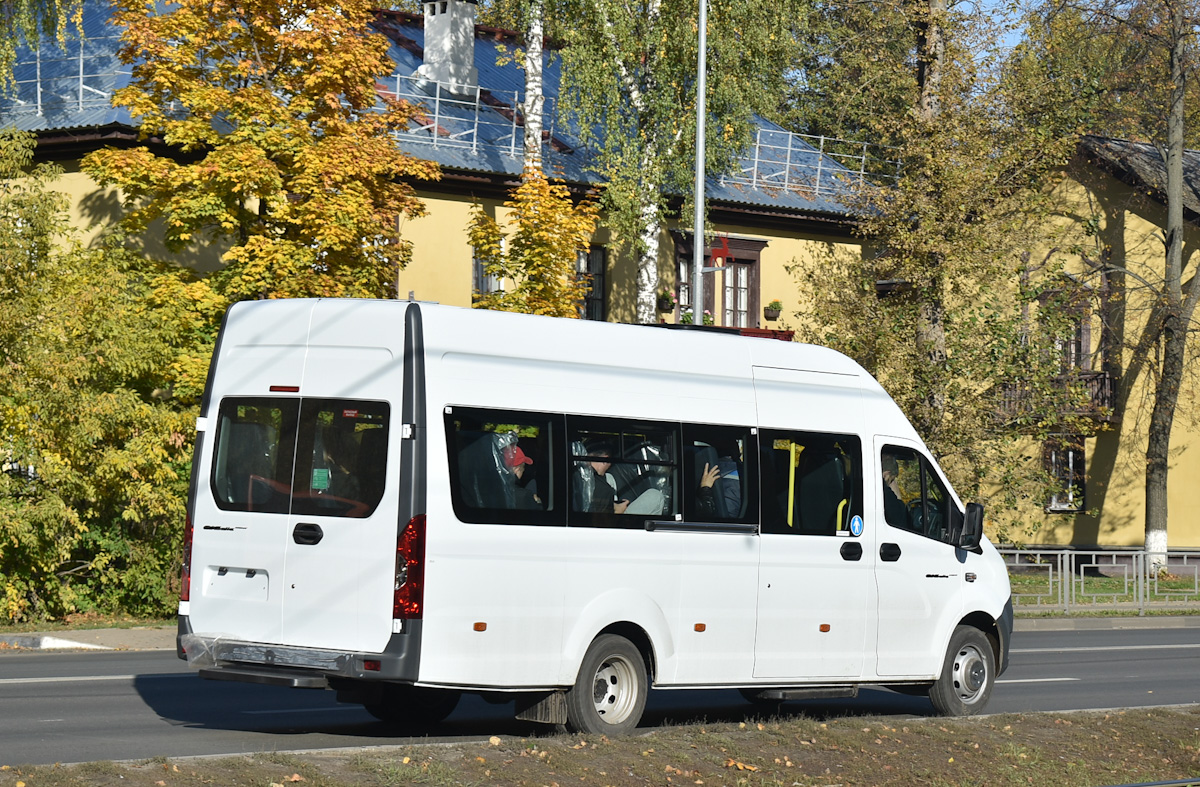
(791, 0, 1092, 536)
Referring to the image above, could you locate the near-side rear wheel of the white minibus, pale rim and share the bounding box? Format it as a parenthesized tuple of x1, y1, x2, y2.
(566, 633, 647, 735)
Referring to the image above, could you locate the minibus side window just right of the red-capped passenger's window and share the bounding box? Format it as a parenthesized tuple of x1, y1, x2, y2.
(566, 416, 679, 528)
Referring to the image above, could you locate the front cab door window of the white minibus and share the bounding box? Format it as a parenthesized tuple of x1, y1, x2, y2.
(880, 445, 962, 543)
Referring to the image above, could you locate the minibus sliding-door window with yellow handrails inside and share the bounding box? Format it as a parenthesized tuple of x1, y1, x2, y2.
(758, 429, 863, 535)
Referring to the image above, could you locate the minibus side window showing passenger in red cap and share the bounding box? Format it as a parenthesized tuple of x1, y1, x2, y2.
(445, 407, 564, 525)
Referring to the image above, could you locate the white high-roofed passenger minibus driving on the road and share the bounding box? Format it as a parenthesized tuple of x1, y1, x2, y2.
(179, 299, 1013, 734)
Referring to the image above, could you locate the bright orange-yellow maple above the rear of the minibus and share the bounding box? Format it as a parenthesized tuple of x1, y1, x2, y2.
(83, 0, 437, 300)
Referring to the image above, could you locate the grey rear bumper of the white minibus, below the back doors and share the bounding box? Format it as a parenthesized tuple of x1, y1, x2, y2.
(176, 615, 421, 689)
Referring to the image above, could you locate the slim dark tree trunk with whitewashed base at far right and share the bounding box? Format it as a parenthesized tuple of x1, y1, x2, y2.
(1145, 4, 1190, 572)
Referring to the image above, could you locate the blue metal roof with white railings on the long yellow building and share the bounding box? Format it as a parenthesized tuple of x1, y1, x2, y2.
(0, 0, 878, 217)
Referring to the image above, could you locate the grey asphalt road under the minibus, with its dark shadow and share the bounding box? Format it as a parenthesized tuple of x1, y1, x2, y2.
(0, 629, 1200, 765)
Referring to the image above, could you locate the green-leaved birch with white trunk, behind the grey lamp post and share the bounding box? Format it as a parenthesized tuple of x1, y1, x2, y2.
(562, 0, 803, 323)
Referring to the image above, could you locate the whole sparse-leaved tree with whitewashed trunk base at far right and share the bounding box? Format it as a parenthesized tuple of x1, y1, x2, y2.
(1027, 0, 1200, 567)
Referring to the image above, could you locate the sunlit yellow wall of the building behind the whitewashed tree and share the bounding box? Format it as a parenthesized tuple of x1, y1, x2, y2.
(1038, 137, 1200, 548)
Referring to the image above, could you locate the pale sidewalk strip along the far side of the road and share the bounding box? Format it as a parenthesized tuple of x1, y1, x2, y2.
(0, 615, 1200, 650)
